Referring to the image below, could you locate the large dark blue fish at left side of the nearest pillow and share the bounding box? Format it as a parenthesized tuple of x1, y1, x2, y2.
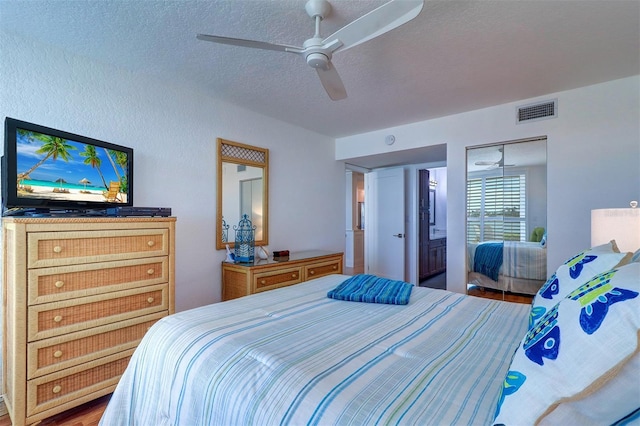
(522, 305, 560, 365)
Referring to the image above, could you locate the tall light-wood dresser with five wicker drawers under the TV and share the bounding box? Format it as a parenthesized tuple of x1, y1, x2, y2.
(2, 218, 175, 426)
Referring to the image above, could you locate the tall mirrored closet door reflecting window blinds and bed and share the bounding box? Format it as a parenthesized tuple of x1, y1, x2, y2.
(467, 137, 547, 295)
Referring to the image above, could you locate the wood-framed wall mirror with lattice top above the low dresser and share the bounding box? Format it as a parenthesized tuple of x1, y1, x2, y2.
(216, 138, 269, 250)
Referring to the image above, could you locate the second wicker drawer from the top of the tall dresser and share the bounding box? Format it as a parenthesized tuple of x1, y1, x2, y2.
(28, 256, 169, 305)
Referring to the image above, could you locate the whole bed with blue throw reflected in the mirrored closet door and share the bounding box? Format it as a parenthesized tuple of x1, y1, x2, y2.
(467, 241, 547, 294)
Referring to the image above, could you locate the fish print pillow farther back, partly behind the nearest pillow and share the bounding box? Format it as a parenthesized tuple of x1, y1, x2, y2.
(529, 241, 631, 328)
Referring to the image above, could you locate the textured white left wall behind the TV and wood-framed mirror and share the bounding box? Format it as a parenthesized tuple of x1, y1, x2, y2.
(0, 32, 345, 311)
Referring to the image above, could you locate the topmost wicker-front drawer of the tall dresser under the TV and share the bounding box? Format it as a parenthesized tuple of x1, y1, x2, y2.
(27, 229, 170, 268)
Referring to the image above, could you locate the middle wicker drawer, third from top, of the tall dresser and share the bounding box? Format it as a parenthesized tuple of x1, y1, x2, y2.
(27, 284, 169, 342)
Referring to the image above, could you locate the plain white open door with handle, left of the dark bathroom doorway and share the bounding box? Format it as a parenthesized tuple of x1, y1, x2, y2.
(364, 167, 405, 280)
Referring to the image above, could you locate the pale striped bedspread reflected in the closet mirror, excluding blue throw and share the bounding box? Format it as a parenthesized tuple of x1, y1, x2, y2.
(468, 241, 547, 282)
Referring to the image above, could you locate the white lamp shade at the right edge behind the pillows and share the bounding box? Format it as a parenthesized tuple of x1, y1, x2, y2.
(591, 208, 640, 252)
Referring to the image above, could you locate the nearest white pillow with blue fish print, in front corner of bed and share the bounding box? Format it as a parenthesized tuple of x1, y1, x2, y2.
(494, 263, 640, 426)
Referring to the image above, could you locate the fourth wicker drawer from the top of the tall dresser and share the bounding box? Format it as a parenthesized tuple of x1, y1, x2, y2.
(27, 312, 166, 379)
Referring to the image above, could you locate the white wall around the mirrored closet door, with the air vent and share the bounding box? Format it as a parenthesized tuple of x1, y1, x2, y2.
(336, 76, 640, 293)
